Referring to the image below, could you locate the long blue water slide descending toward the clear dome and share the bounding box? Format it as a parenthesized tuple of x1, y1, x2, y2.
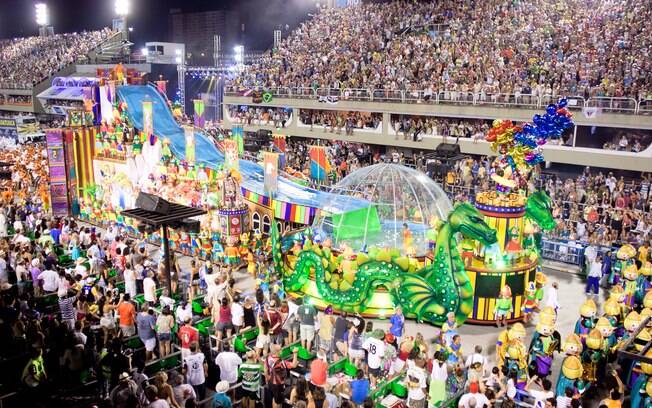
(117, 85, 370, 214)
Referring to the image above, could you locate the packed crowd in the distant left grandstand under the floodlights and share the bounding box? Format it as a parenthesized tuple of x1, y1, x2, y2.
(0, 28, 111, 89)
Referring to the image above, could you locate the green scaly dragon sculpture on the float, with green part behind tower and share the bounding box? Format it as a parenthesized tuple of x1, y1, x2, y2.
(272, 192, 554, 325)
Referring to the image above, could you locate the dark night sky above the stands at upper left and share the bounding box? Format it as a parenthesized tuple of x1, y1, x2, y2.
(0, 0, 316, 50)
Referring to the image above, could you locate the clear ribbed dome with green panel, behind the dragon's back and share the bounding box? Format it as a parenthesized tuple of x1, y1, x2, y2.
(312, 163, 452, 256)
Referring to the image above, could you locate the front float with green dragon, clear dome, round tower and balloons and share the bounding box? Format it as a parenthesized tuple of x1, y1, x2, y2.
(272, 100, 572, 325)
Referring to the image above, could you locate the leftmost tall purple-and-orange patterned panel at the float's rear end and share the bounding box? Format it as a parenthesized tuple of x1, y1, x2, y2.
(45, 129, 68, 217)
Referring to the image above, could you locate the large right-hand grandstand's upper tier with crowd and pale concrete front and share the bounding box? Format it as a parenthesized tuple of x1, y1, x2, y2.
(224, 0, 652, 171)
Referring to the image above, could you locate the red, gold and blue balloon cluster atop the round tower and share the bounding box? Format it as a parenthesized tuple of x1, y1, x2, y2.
(485, 99, 573, 192)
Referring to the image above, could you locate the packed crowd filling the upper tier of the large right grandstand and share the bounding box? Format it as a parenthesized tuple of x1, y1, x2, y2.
(233, 0, 652, 100)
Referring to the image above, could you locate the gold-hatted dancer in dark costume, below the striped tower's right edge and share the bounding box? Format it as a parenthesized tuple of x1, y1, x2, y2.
(528, 307, 561, 378)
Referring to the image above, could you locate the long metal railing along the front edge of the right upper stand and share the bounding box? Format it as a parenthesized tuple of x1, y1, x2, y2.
(224, 85, 652, 115)
